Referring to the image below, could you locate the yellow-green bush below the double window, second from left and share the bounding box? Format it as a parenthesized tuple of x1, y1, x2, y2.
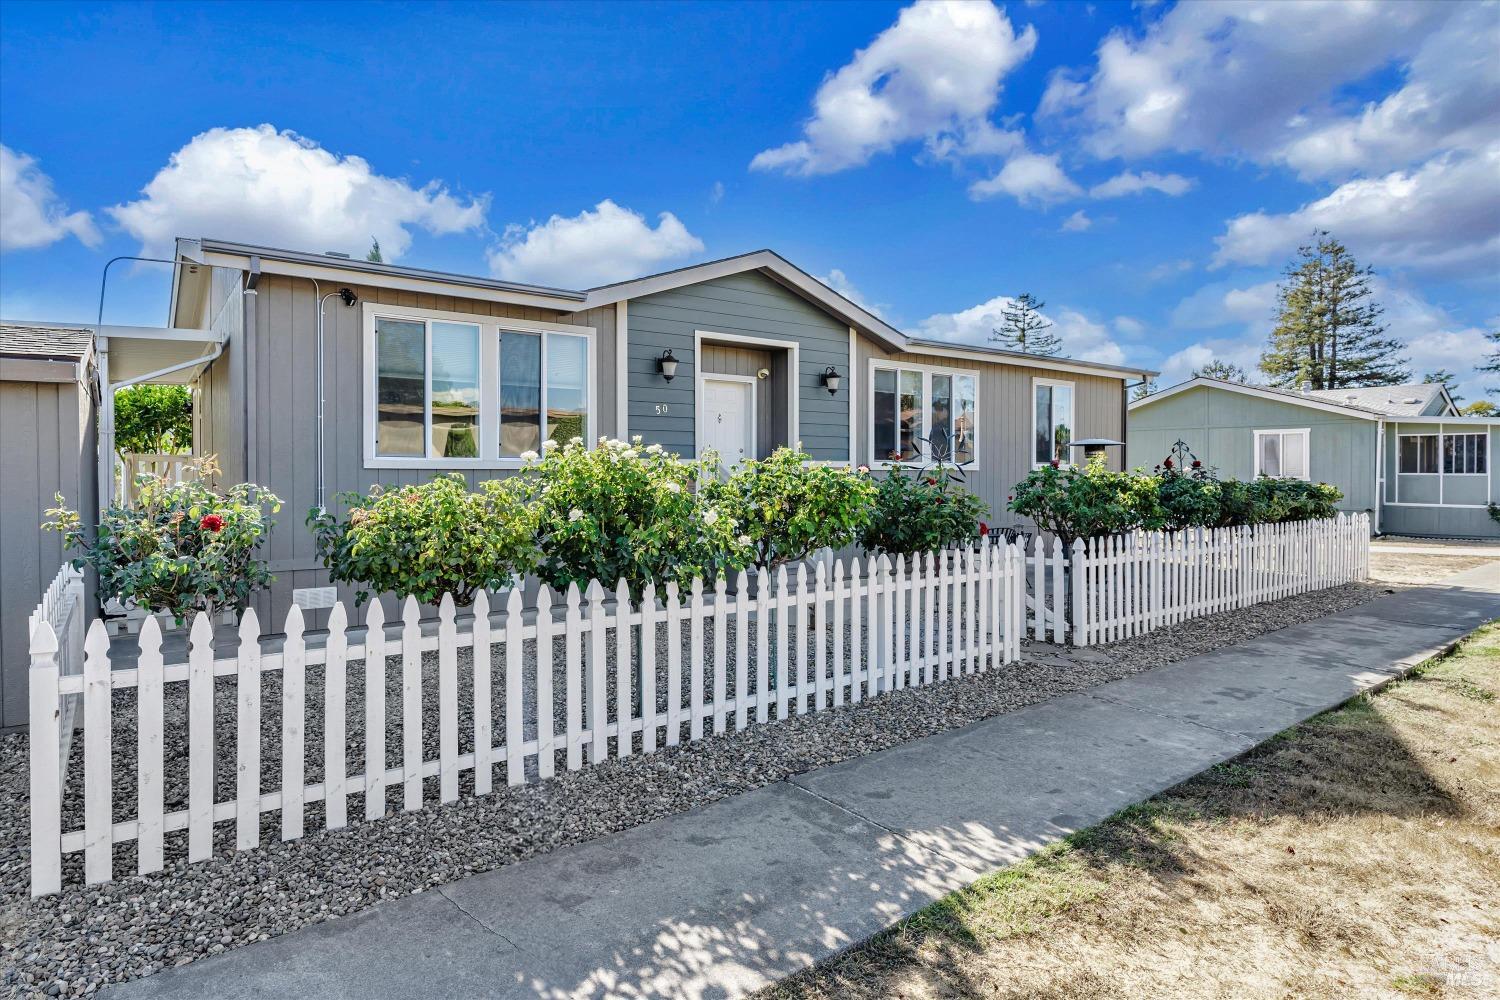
(308, 472, 539, 606)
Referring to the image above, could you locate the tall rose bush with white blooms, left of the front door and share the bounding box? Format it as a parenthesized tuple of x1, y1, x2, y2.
(515, 438, 753, 594)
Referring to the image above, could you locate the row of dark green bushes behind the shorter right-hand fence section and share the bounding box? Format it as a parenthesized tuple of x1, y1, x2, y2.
(1008, 462, 1344, 544)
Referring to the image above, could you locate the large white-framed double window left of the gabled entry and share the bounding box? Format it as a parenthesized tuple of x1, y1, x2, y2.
(365, 303, 596, 469)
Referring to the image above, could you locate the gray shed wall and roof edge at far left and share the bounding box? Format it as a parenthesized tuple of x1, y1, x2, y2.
(0, 322, 98, 729)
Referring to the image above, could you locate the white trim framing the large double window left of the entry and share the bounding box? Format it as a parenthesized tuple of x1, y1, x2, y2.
(362, 303, 600, 469)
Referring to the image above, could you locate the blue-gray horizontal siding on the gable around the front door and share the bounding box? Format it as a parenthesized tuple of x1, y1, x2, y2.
(627, 271, 849, 462)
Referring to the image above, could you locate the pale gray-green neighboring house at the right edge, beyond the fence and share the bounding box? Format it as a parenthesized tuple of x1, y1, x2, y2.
(1127, 378, 1500, 538)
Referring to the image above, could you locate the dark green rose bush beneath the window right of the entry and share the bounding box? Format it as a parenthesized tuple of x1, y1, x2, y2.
(863, 465, 990, 556)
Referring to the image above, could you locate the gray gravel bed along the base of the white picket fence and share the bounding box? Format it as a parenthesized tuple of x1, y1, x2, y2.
(0, 585, 1383, 997)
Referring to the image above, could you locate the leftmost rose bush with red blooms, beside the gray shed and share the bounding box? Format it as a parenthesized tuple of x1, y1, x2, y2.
(44, 456, 281, 624)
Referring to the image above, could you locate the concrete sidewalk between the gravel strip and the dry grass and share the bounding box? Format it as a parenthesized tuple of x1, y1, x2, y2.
(104, 564, 1500, 1000)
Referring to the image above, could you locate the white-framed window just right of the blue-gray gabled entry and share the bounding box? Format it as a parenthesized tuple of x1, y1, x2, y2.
(869, 360, 980, 469)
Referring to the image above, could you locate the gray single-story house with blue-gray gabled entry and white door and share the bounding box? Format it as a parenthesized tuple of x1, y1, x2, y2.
(79, 240, 1151, 621)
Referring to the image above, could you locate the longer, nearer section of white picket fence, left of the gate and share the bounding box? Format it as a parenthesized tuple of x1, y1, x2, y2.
(30, 544, 1025, 895)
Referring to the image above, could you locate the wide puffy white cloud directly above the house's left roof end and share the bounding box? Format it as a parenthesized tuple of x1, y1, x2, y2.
(108, 124, 486, 261)
